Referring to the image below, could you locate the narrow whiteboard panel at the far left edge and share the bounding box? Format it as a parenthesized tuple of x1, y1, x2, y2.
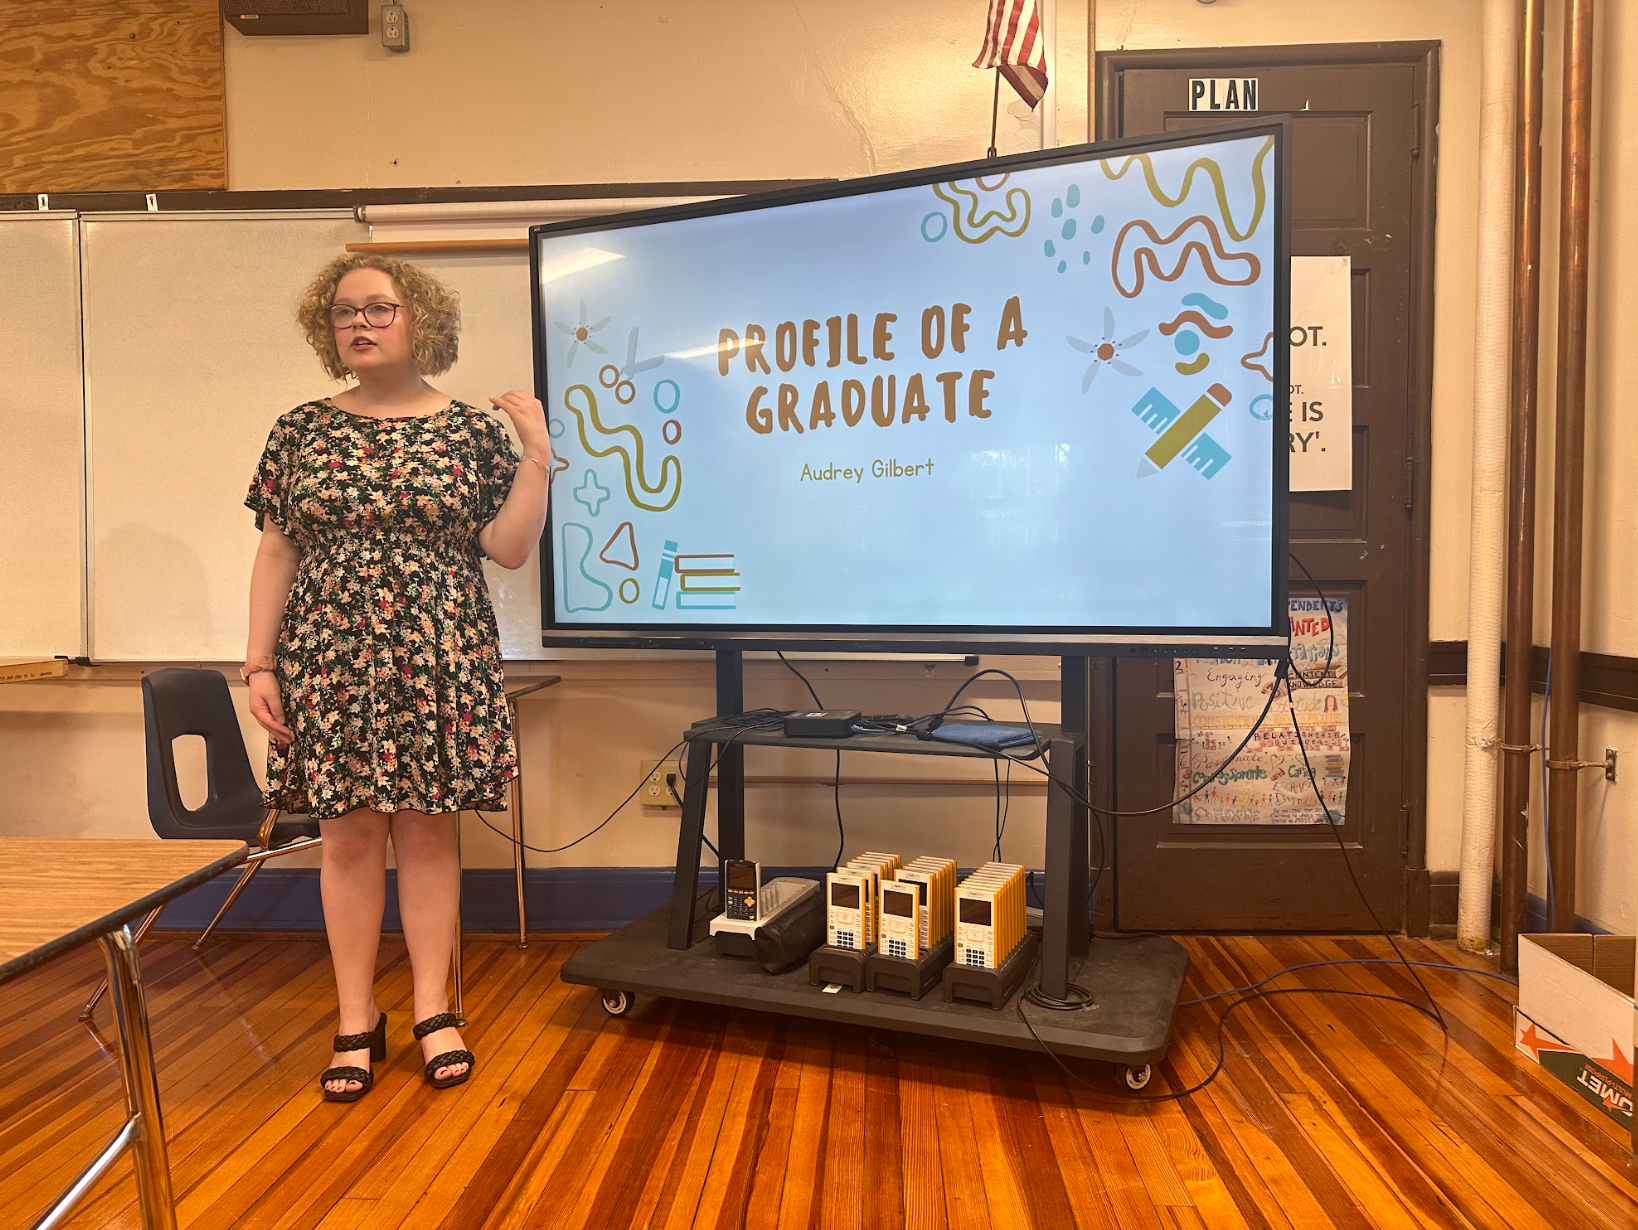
(0, 211, 85, 657)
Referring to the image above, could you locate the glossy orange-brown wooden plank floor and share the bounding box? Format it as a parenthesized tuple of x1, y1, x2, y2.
(0, 937, 1638, 1230)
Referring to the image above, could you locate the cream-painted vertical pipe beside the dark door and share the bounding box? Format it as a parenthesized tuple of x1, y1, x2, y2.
(1456, 0, 1517, 952)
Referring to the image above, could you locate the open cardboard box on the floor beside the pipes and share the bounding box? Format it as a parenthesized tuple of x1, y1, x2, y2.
(1514, 934, 1638, 1132)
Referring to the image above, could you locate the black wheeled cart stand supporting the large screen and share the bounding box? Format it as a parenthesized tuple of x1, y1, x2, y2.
(562, 650, 1189, 1089)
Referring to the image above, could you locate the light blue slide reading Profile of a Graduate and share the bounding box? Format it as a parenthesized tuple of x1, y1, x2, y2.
(534, 131, 1284, 632)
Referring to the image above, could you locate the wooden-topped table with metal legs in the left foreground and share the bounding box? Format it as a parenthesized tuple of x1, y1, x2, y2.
(0, 837, 249, 1230)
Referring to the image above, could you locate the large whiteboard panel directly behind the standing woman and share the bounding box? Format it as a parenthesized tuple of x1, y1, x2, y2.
(70, 210, 969, 662)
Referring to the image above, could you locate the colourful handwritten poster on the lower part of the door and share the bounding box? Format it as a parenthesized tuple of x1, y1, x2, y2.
(1173, 598, 1350, 824)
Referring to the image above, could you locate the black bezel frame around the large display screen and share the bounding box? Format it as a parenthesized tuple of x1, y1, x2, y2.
(529, 115, 1291, 657)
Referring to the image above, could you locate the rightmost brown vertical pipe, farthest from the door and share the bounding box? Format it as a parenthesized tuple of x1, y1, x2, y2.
(1548, 0, 1592, 930)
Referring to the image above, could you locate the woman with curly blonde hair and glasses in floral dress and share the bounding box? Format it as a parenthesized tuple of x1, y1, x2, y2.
(242, 255, 552, 1102)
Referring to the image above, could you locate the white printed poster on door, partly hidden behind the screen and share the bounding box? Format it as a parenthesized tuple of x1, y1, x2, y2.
(1291, 255, 1353, 491)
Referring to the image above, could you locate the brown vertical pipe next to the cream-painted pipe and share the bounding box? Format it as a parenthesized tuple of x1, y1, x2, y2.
(1500, 0, 1546, 973)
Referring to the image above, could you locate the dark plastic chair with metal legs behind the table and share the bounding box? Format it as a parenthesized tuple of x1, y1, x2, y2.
(80, 668, 321, 1020)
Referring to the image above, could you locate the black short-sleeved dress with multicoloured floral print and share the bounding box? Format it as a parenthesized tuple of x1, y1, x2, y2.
(244, 401, 519, 821)
